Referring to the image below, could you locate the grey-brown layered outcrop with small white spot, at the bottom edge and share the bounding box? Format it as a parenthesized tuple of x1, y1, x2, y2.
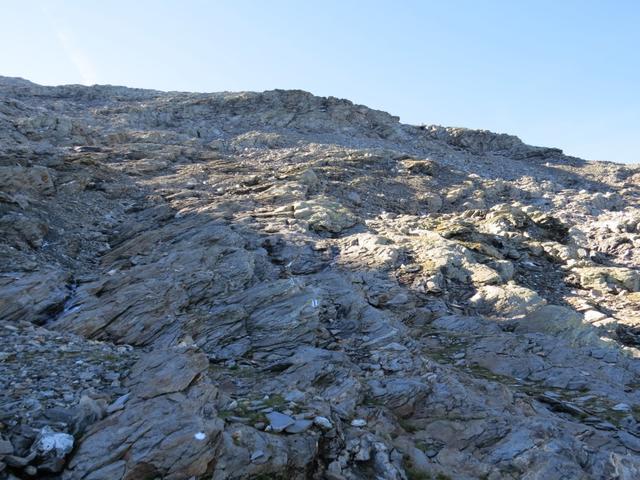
(67, 350, 224, 480)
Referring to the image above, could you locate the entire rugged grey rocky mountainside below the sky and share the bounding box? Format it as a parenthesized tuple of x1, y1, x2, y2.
(0, 77, 640, 480)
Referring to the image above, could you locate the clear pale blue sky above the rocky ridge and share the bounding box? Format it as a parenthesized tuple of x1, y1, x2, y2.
(0, 0, 640, 163)
